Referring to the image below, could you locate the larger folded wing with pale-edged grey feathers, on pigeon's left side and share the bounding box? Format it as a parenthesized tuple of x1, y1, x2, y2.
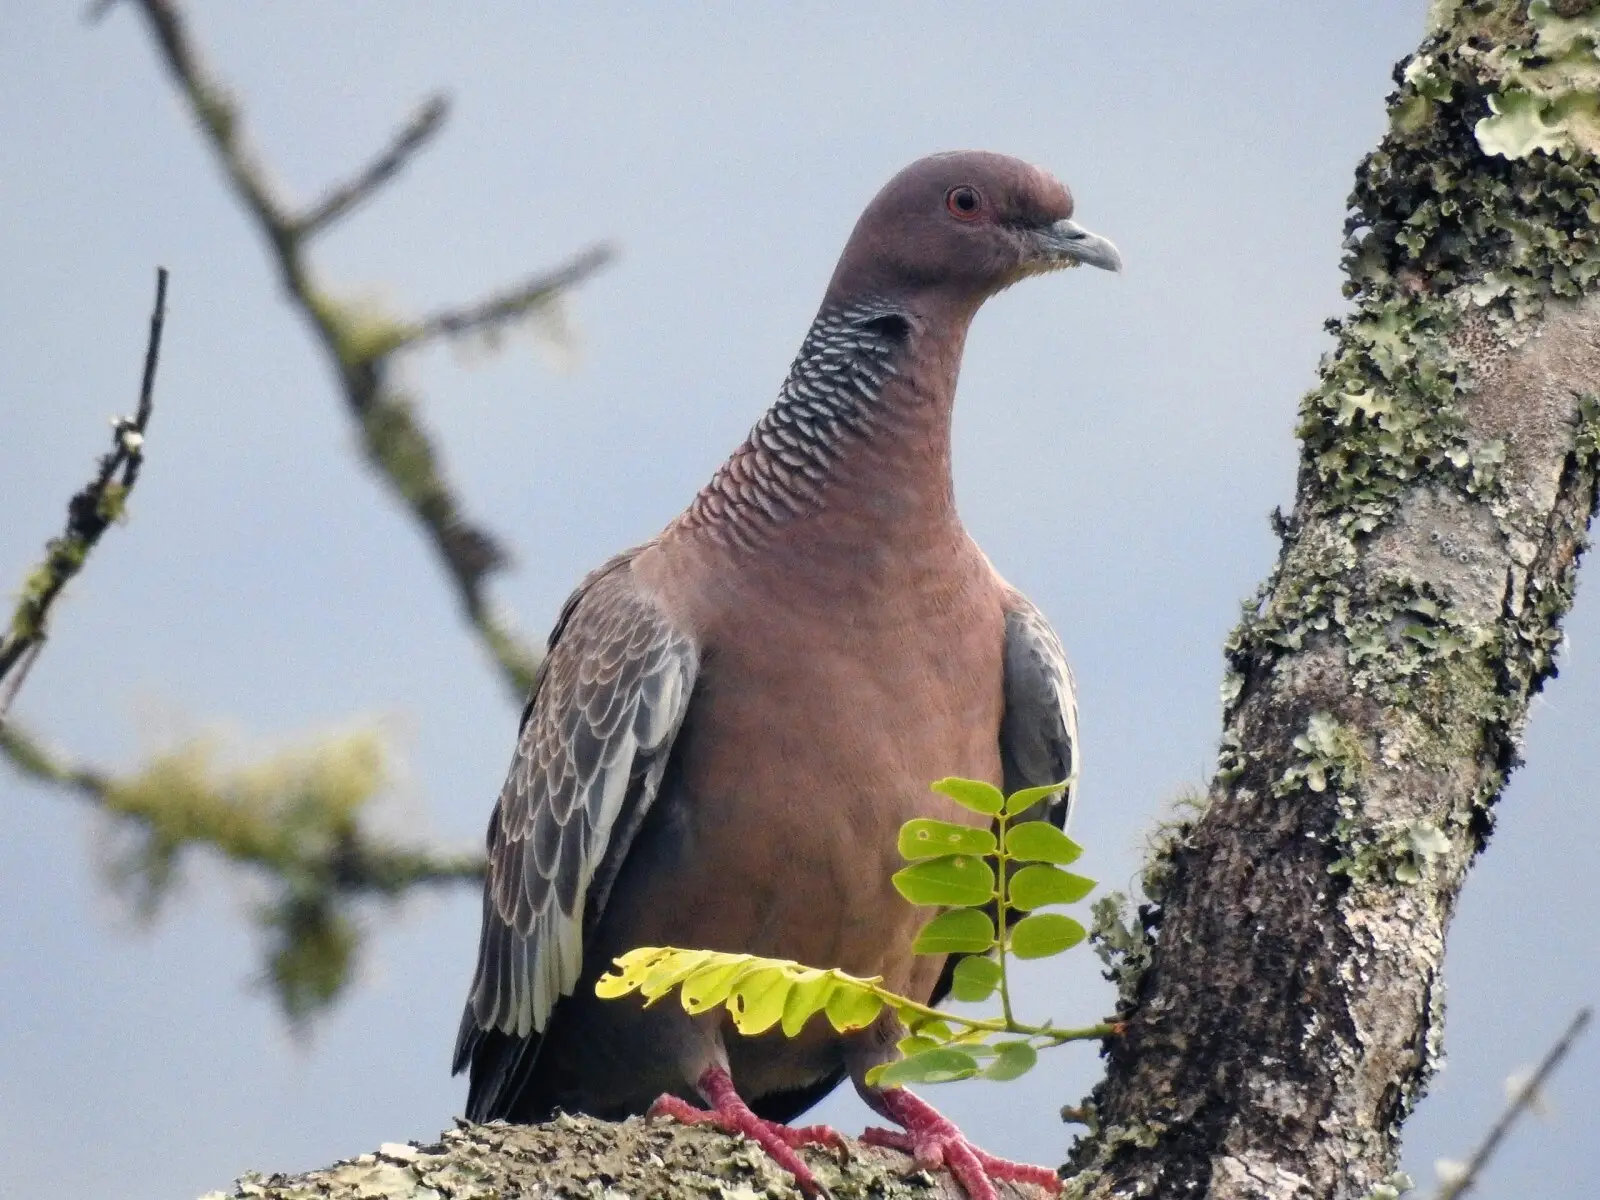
(454, 555, 699, 1120)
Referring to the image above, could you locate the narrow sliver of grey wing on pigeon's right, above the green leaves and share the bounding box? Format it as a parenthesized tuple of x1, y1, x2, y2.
(1000, 594, 1078, 829)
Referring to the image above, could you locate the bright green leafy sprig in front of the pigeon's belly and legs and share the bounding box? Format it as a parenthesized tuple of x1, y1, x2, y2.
(595, 778, 1117, 1086)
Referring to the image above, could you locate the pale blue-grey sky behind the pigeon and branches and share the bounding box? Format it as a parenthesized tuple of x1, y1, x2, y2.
(0, 0, 1600, 1200)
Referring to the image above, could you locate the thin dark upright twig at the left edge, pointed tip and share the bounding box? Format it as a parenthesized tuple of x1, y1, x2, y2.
(0, 267, 166, 730)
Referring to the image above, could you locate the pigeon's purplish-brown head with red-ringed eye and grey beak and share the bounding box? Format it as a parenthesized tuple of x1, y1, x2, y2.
(829, 150, 1122, 307)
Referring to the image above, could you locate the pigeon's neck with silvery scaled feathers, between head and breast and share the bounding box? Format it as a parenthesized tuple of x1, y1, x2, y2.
(682, 299, 968, 563)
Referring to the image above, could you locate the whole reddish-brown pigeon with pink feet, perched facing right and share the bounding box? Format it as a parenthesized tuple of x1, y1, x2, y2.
(456, 152, 1120, 1195)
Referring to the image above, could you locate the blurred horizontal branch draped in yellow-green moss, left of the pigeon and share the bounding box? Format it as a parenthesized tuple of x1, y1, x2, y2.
(0, 726, 483, 1021)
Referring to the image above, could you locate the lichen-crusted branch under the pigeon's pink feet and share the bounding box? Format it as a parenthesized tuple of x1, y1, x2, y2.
(202, 1117, 1037, 1200)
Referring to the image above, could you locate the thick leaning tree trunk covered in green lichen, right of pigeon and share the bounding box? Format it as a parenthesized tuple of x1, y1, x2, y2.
(1069, 0, 1600, 1200)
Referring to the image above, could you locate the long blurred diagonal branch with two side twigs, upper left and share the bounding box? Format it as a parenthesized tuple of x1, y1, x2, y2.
(121, 0, 611, 704)
